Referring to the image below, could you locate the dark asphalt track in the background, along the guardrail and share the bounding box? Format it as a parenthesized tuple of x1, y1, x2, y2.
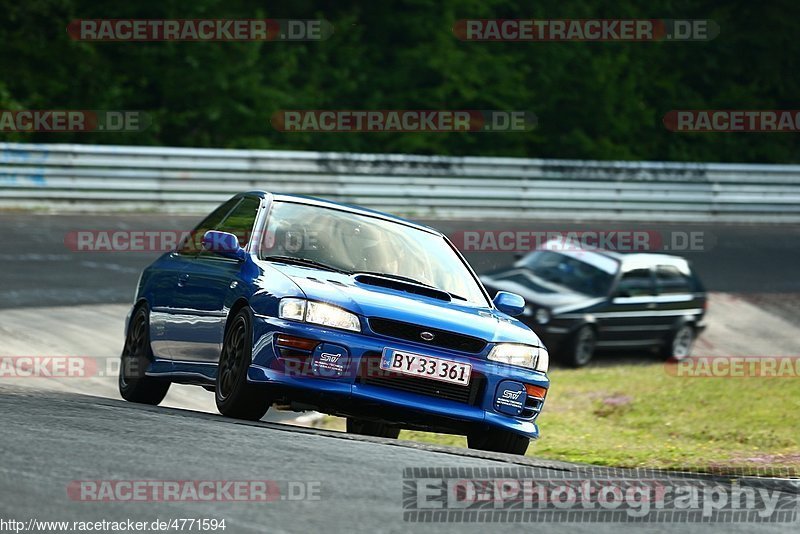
(0, 212, 800, 308)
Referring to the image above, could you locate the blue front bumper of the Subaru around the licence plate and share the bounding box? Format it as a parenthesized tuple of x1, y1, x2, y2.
(248, 315, 550, 439)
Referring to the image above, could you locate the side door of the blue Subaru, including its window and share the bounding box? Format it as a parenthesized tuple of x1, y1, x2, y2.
(172, 196, 261, 363)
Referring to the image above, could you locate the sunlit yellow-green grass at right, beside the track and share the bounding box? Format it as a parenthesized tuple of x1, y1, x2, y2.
(318, 364, 800, 471)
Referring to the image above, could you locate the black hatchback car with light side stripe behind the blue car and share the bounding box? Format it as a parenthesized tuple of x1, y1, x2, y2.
(481, 244, 706, 367)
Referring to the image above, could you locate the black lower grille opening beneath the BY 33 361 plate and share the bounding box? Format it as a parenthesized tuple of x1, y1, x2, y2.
(356, 352, 486, 405)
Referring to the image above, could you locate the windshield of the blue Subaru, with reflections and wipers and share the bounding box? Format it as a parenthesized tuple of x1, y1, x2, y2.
(259, 202, 488, 306)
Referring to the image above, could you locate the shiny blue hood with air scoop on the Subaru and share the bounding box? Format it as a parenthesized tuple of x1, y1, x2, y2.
(272, 263, 541, 346)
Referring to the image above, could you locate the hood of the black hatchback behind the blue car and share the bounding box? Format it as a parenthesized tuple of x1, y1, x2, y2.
(481, 267, 603, 313)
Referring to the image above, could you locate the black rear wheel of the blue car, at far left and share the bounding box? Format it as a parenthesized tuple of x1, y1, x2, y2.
(117, 305, 170, 406)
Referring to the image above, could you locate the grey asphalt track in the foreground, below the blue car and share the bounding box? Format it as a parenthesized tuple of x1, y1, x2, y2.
(0, 385, 798, 534)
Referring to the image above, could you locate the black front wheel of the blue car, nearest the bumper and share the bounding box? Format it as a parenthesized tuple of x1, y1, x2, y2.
(214, 308, 272, 421)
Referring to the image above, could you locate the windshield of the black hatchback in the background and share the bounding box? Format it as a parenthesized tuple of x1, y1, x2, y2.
(523, 250, 619, 297)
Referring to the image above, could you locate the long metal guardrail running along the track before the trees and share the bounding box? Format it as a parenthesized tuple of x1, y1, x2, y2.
(0, 143, 800, 223)
